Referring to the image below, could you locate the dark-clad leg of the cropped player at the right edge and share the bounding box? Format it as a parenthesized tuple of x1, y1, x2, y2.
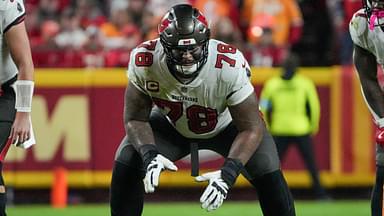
(371, 145, 384, 216)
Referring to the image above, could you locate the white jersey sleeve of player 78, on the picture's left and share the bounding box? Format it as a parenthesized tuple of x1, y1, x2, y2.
(127, 48, 148, 95)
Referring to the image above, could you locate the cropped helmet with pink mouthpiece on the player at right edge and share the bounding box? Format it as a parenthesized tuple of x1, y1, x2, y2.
(363, 0, 384, 30)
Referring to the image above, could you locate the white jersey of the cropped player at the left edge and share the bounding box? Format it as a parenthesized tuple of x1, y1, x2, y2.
(0, 0, 25, 84)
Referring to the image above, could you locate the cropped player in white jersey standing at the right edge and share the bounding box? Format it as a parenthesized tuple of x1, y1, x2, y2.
(349, 0, 384, 216)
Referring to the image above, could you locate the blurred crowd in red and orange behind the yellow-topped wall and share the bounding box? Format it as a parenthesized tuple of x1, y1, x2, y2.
(25, 0, 361, 67)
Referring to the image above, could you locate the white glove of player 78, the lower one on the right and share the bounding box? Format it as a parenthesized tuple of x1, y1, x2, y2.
(195, 170, 229, 211)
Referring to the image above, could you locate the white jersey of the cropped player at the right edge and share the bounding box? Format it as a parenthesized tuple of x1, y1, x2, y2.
(349, 9, 384, 65)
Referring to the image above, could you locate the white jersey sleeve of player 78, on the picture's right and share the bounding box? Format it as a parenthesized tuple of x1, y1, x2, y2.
(223, 51, 254, 106)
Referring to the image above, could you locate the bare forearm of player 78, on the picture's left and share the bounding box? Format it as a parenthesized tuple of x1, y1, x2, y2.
(125, 120, 155, 150)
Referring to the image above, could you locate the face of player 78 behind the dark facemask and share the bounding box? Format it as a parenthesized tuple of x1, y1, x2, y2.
(171, 46, 203, 65)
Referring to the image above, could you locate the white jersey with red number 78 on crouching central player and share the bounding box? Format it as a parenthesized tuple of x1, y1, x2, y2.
(128, 39, 257, 138)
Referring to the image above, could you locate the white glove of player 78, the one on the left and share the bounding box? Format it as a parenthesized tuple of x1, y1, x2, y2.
(143, 154, 177, 193)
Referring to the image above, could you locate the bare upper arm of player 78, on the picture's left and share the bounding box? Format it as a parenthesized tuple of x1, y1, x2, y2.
(124, 82, 152, 123)
